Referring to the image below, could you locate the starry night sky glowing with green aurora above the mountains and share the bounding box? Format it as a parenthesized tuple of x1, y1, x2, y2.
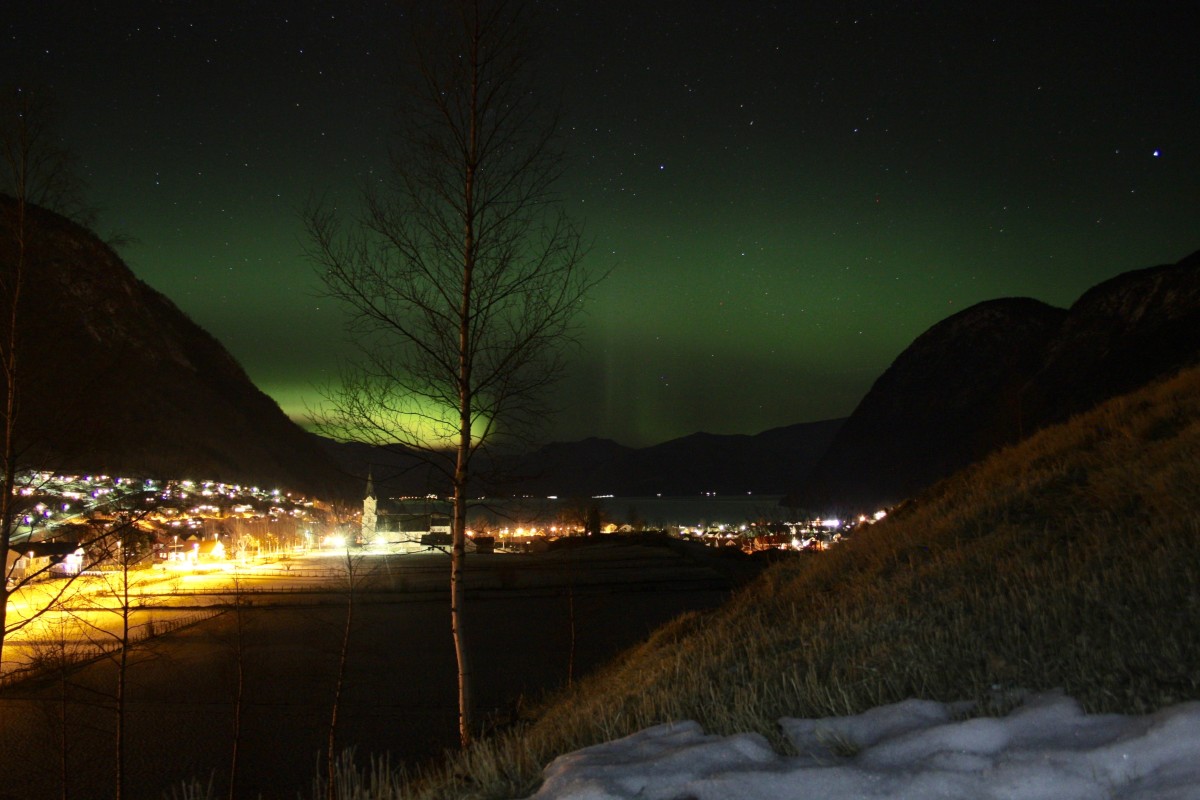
(0, 0, 1200, 446)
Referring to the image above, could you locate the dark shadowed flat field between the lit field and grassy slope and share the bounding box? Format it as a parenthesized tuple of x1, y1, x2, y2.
(0, 554, 727, 799)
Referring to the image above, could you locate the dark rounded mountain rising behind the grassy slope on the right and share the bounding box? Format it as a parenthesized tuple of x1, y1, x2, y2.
(788, 253, 1200, 509)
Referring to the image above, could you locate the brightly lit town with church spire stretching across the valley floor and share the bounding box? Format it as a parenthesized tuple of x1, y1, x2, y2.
(6, 473, 883, 582)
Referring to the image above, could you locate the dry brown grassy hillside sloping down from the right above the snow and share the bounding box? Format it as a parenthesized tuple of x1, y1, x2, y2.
(364, 369, 1200, 798)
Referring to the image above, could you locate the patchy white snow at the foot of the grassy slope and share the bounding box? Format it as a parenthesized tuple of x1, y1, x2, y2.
(533, 692, 1200, 800)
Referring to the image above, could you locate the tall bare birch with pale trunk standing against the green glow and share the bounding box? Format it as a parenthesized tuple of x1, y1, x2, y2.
(305, 0, 599, 745)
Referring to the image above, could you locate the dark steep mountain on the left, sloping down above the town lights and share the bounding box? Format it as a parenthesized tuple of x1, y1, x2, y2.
(0, 198, 350, 498)
